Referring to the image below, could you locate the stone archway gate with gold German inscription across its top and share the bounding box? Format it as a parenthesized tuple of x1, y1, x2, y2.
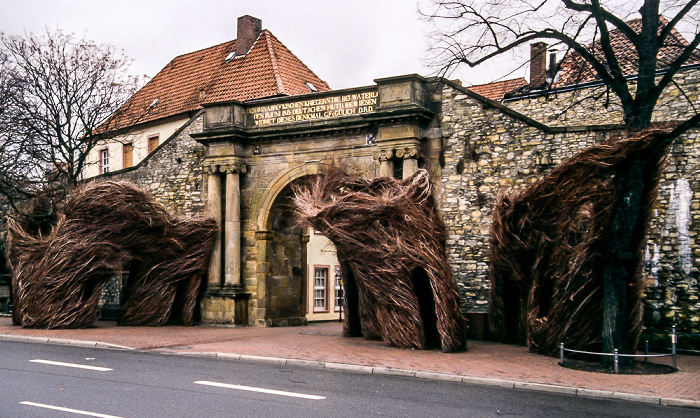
(192, 75, 440, 326)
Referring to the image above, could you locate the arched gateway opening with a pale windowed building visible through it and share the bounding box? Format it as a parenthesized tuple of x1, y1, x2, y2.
(257, 162, 343, 326)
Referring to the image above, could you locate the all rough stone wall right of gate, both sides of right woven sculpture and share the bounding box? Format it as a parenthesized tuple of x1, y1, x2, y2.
(441, 73, 700, 333)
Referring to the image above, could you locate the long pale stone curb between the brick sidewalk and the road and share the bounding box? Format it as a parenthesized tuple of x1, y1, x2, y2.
(0, 334, 700, 409)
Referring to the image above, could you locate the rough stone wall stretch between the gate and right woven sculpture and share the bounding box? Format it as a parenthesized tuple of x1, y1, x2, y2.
(441, 87, 604, 313)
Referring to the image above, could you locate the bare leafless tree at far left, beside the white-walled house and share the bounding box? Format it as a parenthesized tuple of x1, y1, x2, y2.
(0, 29, 139, 209)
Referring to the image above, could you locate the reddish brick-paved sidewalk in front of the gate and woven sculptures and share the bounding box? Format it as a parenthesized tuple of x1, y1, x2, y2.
(0, 317, 700, 408)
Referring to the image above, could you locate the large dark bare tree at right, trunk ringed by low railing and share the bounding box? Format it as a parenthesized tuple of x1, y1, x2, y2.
(422, 0, 700, 353)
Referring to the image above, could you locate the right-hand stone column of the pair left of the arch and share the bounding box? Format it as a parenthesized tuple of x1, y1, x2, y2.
(221, 165, 246, 286)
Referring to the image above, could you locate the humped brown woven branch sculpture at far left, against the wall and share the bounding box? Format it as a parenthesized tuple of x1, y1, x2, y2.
(8, 181, 218, 328)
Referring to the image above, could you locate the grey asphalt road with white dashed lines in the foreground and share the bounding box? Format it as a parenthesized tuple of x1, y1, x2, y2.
(0, 341, 699, 418)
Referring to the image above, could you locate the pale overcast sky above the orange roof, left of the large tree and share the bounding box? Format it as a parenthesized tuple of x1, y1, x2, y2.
(0, 0, 525, 89)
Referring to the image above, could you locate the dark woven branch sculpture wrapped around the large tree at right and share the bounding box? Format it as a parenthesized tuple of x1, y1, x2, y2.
(490, 131, 667, 355)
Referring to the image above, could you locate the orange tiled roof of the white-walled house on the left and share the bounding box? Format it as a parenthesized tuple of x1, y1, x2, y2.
(108, 30, 330, 130)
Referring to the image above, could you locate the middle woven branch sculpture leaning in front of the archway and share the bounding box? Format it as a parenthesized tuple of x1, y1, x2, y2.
(295, 168, 467, 352)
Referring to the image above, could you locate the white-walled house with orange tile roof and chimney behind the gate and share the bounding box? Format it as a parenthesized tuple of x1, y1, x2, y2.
(86, 16, 331, 177)
